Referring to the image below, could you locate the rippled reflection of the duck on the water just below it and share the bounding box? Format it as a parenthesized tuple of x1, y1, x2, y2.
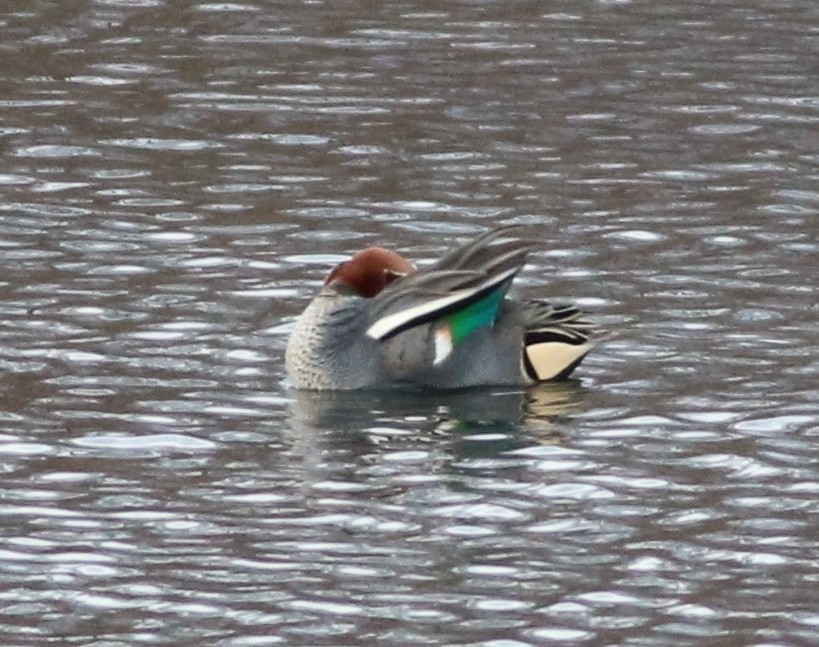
(291, 380, 584, 458)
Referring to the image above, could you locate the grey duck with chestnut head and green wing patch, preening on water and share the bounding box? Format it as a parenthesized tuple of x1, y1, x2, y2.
(285, 225, 604, 391)
